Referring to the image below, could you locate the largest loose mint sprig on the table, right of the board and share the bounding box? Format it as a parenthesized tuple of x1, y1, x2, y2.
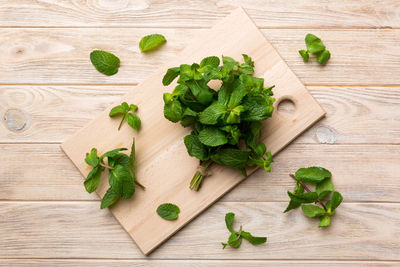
(284, 167, 343, 227)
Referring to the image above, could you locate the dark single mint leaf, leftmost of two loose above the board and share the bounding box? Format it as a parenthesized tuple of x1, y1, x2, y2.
(90, 50, 120, 76)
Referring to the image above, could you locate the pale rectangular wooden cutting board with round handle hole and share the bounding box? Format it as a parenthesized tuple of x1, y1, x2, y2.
(62, 8, 325, 255)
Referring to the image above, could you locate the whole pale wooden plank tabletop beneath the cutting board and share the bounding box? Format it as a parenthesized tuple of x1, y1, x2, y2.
(0, 0, 400, 266)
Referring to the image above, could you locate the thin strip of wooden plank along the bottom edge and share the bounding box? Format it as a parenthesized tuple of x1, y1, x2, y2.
(0, 259, 399, 267)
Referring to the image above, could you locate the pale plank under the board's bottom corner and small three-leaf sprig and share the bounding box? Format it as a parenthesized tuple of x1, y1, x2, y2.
(0, 202, 400, 261)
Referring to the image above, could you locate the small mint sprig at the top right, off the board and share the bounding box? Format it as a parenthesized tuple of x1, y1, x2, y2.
(299, 33, 331, 65)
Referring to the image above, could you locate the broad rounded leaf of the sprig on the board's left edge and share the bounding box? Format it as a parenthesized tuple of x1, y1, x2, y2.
(109, 165, 135, 199)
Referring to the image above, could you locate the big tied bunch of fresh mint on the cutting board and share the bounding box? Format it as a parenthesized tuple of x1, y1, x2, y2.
(163, 55, 275, 191)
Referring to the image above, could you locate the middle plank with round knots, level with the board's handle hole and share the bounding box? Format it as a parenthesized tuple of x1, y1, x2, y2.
(0, 85, 400, 144)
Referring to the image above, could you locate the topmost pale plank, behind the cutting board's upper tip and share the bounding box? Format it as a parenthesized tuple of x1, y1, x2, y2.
(0, 0, 400, 28)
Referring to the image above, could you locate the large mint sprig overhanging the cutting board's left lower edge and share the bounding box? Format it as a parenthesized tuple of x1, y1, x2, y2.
(84, 139, 141, 209)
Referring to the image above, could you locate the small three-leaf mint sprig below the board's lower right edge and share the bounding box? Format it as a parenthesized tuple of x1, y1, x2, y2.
(221, 212, 267, 249)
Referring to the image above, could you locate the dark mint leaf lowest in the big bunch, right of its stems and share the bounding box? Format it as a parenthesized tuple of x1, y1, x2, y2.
(211, 148, 249, 170)
